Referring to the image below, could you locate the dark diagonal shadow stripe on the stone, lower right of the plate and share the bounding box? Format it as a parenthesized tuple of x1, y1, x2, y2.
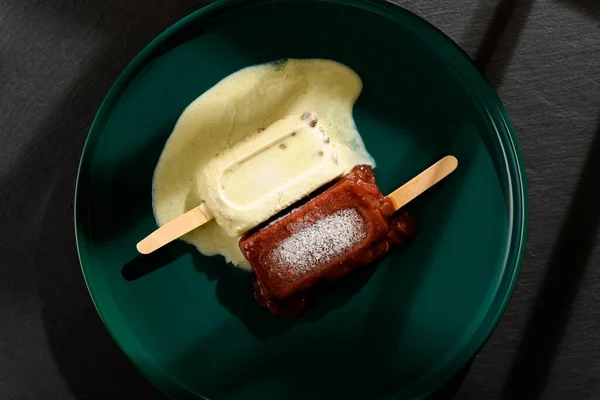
(502, 118, 600, 400)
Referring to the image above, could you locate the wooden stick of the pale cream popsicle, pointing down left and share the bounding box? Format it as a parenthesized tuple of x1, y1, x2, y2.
(136, 206, 212, 254)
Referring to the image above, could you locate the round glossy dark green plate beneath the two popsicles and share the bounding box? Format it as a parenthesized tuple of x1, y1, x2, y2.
(75, 0, 527, 399)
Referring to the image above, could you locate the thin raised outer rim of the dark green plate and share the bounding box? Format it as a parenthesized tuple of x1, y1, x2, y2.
(73, 0, 529, 398)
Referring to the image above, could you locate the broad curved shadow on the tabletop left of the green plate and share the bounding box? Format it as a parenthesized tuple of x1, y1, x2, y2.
(0, 0, 213, 400)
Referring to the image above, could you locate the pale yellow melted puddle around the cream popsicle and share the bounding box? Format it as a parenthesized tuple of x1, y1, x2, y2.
(153, 60, 375, 269)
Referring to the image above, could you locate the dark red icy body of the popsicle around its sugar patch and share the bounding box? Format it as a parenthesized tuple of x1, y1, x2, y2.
(240, 165, 416, 315)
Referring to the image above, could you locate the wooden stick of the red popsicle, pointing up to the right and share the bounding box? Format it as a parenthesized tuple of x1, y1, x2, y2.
(387, 156, 458, 210)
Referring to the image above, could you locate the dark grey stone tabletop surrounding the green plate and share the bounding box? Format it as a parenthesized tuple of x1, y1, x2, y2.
(0, 0, 600, 400)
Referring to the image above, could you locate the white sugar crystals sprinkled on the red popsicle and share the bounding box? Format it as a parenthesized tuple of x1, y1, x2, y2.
(270, 208, 367, 276)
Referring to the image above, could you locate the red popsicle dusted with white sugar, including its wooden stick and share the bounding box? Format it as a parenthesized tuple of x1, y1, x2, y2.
(240, 159, 456, 315)
